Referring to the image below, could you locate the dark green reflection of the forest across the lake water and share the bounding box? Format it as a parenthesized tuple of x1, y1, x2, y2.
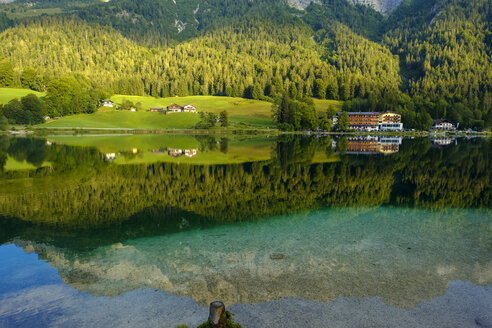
(0, 137, 492, 227)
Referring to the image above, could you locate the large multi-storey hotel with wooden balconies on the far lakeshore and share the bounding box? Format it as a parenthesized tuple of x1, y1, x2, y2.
(332, 112, 403, 131)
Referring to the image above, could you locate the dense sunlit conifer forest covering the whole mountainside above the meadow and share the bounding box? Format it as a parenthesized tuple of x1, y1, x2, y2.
(0, 0, 492, 130)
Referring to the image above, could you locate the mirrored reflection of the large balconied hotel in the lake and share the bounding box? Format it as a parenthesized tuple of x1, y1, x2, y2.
(345, 136, 402, 155)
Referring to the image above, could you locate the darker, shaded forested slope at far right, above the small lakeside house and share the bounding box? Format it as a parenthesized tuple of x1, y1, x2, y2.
(383, 0, 492, 127)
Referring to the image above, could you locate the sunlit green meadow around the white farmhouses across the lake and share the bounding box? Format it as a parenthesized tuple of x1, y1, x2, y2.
(41, 95, 342, 129)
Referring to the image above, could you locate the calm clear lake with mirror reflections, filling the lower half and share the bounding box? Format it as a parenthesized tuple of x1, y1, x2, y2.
(0, 135, 492, 327)
